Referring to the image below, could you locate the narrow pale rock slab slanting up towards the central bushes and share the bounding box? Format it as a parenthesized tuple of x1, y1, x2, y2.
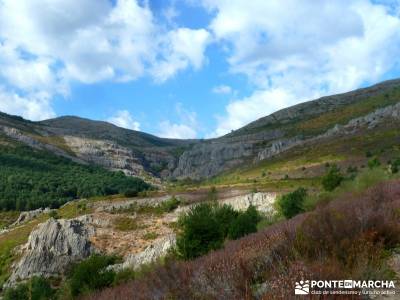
(111, 234, 176, 271)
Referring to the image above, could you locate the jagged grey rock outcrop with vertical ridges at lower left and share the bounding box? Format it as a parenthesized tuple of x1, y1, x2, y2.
(8, 218, 95, 285)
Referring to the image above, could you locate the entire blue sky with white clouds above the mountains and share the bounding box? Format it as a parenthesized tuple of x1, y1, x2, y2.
(0, 0, 400, 138)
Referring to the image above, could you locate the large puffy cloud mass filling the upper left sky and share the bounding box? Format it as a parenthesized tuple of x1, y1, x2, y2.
(0, 0, 209, 119)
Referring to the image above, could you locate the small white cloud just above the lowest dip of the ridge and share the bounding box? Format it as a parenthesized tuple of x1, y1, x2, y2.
(158, 103, 198, 139)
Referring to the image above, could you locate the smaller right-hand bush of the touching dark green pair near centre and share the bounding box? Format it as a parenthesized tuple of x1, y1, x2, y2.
(228, 205, 261, 240)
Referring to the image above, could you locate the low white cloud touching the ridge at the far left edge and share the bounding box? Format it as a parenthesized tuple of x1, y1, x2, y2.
(0, 86, 55, 121)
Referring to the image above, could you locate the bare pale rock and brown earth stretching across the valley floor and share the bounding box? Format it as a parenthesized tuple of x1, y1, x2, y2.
(6, 191, 276, 286)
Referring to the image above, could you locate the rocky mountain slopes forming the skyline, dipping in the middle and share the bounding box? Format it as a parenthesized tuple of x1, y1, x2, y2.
(0, 80, 400, 180)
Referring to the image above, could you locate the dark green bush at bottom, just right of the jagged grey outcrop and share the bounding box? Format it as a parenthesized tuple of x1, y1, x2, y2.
(68, 255, 116, 297)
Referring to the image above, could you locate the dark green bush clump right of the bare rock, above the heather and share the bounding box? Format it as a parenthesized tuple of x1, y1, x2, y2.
(177, 203, 260, 259)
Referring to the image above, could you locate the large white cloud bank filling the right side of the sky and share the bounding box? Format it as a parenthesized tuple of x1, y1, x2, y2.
(203, 0, 400, 135)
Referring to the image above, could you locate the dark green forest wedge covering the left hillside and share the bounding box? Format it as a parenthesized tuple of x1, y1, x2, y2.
(0, 146, 150, 210)
